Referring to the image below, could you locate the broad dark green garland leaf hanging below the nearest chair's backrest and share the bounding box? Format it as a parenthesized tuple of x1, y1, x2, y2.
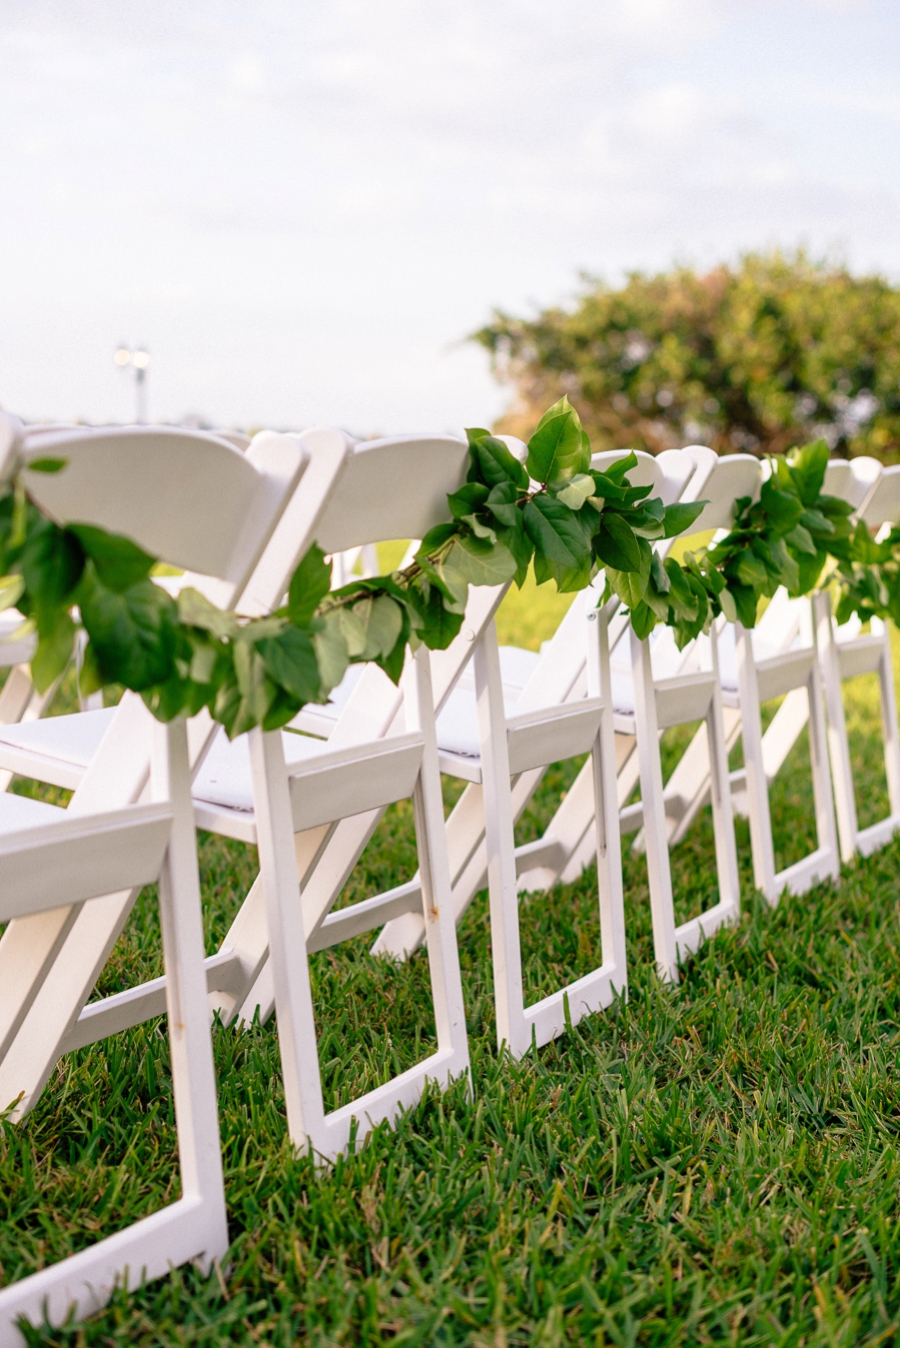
(79, 563, 178, 693)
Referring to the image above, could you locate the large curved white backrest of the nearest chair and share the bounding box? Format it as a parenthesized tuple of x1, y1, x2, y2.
(20, 427, 306, 586)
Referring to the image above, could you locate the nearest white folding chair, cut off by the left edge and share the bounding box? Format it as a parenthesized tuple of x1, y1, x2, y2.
(0, 431, 249, 1345)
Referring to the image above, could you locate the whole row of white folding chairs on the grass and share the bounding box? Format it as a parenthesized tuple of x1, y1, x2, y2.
(0, 421, 900, 1344)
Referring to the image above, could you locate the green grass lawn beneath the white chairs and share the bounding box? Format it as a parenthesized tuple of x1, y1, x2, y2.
(0, 609, 900, 1348)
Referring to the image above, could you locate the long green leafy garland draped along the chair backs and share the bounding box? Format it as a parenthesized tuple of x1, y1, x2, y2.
(0, 398, 883, 737)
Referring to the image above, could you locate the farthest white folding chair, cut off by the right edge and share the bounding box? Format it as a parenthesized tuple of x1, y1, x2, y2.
(814, 460, 900, 861)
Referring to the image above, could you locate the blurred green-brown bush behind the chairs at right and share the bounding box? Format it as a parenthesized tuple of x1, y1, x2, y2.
(473, 251, 900, 462)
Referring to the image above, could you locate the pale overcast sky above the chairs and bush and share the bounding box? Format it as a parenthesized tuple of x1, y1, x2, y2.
(0, 0, 900, 433)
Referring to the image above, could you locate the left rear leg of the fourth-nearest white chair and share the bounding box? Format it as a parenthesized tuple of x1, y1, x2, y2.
(631, 631, 679, 983)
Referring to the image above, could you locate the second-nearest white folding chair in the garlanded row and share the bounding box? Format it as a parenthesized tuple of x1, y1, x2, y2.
(235, 437, 482, 1159)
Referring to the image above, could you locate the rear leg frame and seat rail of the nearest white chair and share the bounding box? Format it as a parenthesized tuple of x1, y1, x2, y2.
(0, 712, 229, 1348)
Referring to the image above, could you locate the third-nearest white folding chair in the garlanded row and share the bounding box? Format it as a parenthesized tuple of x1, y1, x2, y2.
(375, 454, 711, 1008)
